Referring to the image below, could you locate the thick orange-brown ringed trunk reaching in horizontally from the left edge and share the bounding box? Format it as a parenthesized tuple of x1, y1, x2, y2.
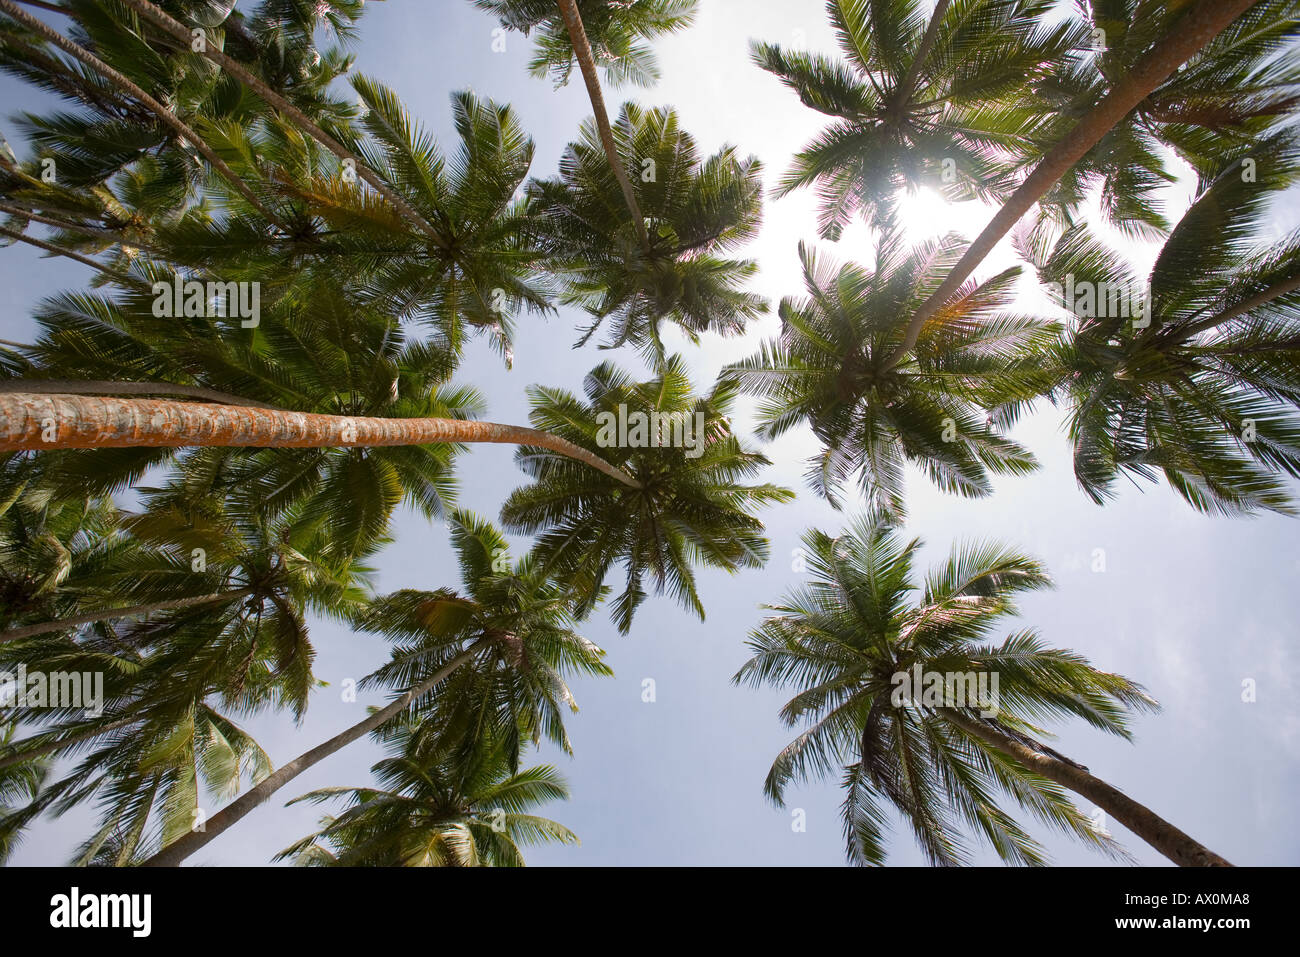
(0, 393, 641, 489)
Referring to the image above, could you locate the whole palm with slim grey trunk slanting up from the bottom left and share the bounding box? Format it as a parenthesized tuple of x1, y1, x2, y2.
(146, 512, 611, 866)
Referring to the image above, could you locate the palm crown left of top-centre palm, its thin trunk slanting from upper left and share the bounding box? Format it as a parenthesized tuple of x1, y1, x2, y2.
(304, 77, 550, 364)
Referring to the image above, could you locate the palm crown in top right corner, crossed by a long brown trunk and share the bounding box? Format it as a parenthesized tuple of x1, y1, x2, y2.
(1034, 0, 1300, 237)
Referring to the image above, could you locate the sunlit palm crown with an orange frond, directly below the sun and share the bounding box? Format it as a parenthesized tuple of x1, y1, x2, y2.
(724, 230, 1054, 518)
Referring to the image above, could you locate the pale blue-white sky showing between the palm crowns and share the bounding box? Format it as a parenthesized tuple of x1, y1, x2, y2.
(0, 0, 1300, 866)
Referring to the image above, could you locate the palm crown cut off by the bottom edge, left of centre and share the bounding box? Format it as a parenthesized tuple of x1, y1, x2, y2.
(276, 724, 580, 867)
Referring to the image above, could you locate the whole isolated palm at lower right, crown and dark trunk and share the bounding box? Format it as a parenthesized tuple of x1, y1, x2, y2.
(735, 516, 1227, 866)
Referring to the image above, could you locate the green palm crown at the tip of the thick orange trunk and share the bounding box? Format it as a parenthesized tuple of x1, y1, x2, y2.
(502, 356, 794, 633)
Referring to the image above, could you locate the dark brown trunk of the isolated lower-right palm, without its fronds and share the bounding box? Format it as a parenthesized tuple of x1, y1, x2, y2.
(939, 707, 1232, 867)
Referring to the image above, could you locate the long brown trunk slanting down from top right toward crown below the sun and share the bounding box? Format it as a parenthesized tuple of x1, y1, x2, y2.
(885, 0, 1257, 368)
